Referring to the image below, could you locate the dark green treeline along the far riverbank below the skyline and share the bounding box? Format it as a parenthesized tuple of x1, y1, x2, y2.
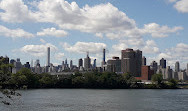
(0, 61, 177, 89)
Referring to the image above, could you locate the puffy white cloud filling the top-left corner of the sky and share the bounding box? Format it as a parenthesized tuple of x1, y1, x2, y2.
(0, 0, 35, 23)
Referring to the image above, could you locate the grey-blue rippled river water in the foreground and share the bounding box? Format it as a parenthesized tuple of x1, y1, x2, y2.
(0, 89, 188, 111)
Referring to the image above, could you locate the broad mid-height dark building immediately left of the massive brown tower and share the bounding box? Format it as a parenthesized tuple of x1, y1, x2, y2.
(107, 57, 121, 72)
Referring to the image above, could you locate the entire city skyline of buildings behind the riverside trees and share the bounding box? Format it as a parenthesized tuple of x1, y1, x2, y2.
(0, 47, 188, 80)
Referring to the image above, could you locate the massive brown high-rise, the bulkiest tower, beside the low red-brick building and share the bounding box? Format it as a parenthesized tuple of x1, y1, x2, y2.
(121, 49, 142, 77)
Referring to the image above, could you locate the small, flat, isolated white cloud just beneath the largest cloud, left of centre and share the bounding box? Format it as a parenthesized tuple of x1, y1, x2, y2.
(37, 27, 68, 37)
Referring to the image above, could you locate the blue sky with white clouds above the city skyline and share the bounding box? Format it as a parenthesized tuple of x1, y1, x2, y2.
(0, 0, 188, 68)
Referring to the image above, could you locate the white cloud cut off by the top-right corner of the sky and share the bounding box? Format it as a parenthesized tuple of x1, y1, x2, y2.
(174, 0, 188, 13)
